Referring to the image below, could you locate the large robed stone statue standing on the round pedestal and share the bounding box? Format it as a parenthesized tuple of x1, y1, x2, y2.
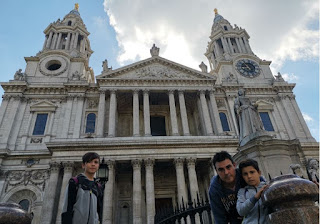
(234, 89, 263, 146)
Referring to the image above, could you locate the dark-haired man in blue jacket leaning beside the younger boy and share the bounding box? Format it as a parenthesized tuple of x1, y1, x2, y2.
(209, 151, 242, 224)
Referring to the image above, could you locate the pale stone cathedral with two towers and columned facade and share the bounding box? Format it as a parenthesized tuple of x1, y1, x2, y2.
(0, 4, 318, 224)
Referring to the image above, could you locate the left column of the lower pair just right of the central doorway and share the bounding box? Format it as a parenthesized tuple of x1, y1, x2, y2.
(174, 158, 188, 205)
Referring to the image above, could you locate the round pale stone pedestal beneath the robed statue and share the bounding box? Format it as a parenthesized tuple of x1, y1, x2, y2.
(233, 136, 305, 178)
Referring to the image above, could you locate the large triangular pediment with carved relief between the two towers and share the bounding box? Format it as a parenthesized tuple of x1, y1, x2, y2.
(96, 56, 216, 80)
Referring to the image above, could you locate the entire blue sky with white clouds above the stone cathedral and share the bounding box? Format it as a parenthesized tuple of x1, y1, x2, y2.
(0, 0, 319, 141)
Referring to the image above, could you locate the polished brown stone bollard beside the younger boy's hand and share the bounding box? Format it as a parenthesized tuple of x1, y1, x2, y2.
(262, 174, 319, 224)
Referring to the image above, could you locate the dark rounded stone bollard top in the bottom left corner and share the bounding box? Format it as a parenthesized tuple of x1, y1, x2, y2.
(0, 203, 32, 224)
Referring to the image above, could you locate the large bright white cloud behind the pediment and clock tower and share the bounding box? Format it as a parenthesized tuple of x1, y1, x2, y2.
(104, 0, 319, 74)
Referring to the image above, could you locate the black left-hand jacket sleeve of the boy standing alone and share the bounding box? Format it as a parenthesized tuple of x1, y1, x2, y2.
(61, 179, 77, 224)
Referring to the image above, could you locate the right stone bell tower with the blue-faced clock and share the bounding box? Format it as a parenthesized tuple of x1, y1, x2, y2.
(205, 9, 274, 83)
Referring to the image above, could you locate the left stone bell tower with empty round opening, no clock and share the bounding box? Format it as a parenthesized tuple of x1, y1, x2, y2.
(25, 4, 94, 83)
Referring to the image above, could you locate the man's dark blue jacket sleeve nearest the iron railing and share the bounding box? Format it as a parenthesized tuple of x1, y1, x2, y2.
(209, 189, 228, 224)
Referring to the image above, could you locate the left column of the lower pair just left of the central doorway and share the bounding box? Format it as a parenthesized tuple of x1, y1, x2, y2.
(131, 159, 142, 224)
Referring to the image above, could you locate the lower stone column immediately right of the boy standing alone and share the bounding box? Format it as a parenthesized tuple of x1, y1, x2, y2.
(102, 160, 116, 224)
